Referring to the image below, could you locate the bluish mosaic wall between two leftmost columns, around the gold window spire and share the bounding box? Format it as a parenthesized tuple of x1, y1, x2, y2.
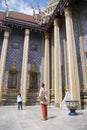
(4, 29, 24, 87)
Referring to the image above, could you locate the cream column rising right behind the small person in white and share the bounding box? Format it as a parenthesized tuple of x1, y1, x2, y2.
(21, 29, 30, 105)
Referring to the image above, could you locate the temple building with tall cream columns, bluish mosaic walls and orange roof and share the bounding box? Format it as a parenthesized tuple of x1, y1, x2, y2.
(0, 0, 87, 109)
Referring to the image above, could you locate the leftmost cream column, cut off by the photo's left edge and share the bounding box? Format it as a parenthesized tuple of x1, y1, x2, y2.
(0, 31, 9, 102)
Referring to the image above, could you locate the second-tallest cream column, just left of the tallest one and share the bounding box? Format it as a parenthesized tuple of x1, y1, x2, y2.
(54, 18, 62, 106)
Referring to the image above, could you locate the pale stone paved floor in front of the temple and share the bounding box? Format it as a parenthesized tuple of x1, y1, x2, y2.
(0, 106, 87, 130)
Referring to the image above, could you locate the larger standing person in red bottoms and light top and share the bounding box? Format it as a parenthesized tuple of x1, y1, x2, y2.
(39, 83, 47, 120)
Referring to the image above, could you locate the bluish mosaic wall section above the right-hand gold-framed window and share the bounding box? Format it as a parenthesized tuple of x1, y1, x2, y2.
(28, 31, 42, 71)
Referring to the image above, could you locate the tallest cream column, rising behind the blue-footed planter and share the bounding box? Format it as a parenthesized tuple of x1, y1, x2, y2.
(65, 8, 80, 100)
